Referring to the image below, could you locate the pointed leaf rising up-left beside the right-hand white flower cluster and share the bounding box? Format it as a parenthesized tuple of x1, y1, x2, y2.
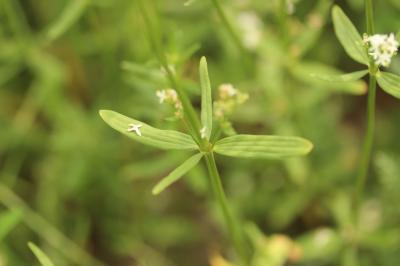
(332, 6, 369, 65)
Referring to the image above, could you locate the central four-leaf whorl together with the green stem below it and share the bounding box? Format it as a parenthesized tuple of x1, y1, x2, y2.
(100, 54, 312, 263)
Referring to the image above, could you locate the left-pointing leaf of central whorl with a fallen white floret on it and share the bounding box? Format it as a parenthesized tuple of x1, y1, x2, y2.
(100, 110, 197, 150)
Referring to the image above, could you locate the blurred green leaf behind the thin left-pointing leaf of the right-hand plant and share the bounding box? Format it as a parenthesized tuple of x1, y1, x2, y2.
(291, 62, 367, 95)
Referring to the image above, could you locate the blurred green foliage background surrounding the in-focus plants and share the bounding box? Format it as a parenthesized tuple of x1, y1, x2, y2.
(0, 0, 400, 266)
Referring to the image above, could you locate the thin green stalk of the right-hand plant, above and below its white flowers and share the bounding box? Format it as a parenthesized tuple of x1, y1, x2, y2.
(355, 0, 378, 212)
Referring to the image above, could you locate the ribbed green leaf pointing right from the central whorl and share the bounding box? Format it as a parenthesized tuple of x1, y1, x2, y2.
(214, 135, 313, 159)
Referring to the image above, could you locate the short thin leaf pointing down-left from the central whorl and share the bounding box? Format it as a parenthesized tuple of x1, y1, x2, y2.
(153, 153, 203, 195)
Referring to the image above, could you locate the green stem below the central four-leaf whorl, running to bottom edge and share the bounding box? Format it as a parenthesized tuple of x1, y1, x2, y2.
(205, 152, 249, 265)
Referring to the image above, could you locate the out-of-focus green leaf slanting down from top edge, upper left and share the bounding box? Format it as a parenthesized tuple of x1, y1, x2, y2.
(46, 0, 89, 41)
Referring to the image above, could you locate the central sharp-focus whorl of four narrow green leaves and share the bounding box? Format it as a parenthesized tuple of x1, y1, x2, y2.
(100, 57, 313, 194)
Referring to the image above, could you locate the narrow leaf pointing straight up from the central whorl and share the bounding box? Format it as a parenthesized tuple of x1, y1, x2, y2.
(200, 56, 212, 139)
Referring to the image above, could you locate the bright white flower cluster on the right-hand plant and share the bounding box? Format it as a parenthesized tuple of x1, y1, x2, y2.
(364, 33, 399, 67)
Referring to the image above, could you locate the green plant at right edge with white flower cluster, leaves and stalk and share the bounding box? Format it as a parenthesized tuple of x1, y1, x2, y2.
(318, 0, 400, 208)
